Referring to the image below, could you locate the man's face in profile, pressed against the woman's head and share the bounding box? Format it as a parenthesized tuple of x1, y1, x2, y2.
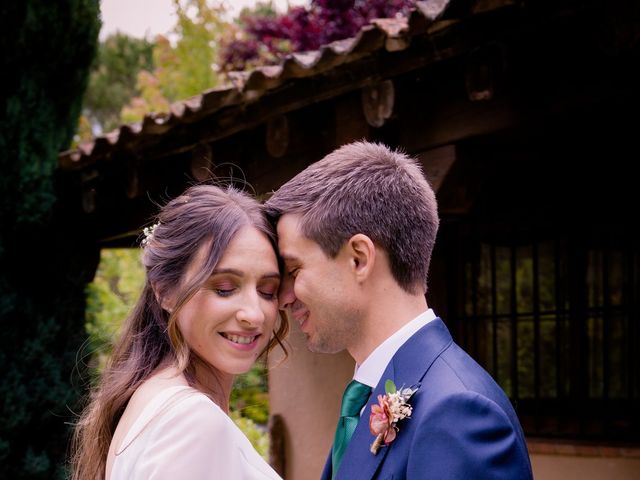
(278, 214, 359, 353)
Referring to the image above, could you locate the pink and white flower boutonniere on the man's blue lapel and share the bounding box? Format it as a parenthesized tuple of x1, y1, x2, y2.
(369, 380, 419, 455)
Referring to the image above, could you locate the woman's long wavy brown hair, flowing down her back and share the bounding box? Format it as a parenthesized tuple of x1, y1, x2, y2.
(71, 185, 288, 480)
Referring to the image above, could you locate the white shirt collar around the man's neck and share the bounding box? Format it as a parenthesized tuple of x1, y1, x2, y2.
(353, 309, 436, 396)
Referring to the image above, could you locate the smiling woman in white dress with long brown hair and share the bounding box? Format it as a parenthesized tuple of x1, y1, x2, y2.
(71, 185, 288, 480)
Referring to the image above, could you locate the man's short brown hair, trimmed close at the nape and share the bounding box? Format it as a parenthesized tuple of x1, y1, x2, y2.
(266, 142, 439, 293)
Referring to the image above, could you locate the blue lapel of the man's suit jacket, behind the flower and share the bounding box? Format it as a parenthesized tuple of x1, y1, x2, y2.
(332, 318, 453, 479)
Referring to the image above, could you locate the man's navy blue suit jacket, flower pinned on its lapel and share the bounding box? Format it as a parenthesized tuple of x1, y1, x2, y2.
(322, 318, 533, 480)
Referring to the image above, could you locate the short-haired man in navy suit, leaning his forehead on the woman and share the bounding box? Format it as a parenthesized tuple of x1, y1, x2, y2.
(266, 142, 532, 480)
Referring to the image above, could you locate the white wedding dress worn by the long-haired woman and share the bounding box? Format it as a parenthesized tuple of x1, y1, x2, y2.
(110, 386, 281, 480)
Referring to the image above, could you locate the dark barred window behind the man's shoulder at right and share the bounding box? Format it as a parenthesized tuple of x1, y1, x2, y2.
(455, 226, 640, 441)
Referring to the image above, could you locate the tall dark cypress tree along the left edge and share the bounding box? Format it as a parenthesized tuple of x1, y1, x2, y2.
(0, 0, 100, 479)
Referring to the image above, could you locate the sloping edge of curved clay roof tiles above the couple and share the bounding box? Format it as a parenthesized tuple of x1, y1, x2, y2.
(59, 0, 514, 170)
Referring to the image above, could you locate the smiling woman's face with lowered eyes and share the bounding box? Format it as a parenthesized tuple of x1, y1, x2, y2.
(178, 227, 280, 375)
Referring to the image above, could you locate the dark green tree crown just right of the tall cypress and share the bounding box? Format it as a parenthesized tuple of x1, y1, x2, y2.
(83, 32, 153, 131)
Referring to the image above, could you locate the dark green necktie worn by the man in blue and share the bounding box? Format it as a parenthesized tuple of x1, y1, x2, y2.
(331, 380, 371, 478)
